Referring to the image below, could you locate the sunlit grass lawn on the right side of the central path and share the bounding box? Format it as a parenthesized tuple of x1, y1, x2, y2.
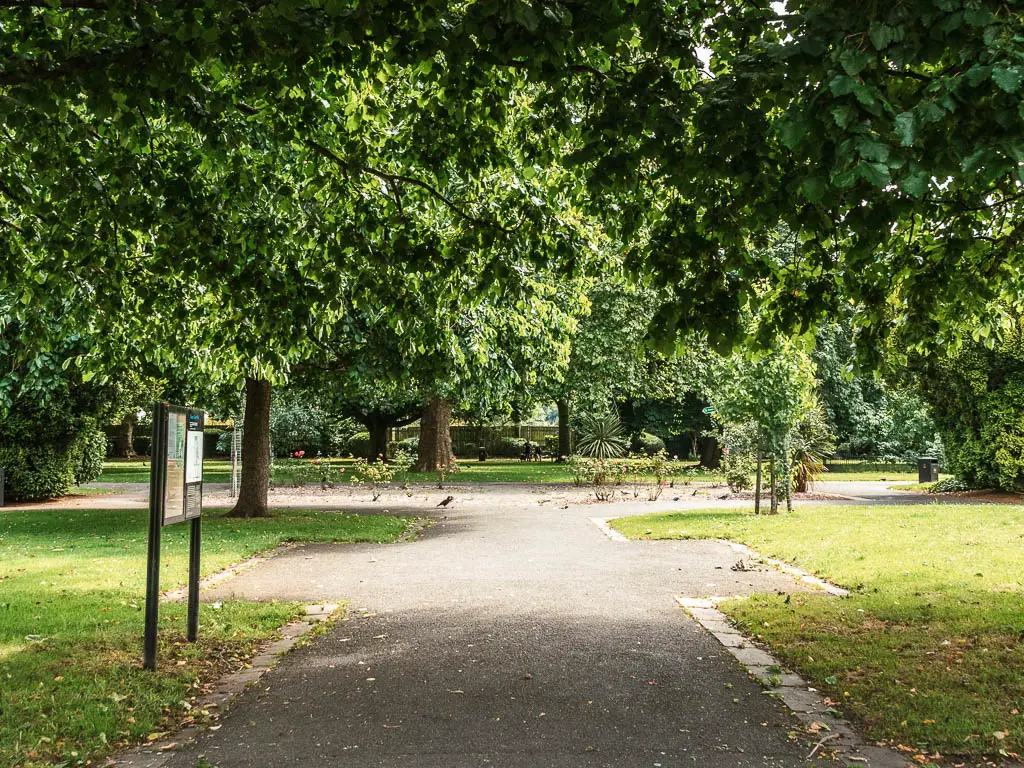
(612, 504, 1024, 756)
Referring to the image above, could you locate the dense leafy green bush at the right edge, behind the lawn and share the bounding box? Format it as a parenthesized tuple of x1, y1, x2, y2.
(911, 321, 1024, 490)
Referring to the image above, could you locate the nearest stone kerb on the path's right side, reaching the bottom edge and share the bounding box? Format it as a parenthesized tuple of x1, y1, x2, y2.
(676, 597, 911, 768)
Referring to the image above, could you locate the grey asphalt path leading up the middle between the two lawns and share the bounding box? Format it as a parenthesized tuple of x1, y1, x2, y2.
(153, 501, 839, 768)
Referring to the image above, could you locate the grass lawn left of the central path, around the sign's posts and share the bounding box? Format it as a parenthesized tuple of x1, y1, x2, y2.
(0, 510, 410, 766)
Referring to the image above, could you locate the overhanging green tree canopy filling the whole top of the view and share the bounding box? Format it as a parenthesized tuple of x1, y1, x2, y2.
(0, 0, 1024, 367)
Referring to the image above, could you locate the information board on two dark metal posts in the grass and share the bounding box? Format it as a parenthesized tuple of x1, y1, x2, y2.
(142, 402, 204, 670)
